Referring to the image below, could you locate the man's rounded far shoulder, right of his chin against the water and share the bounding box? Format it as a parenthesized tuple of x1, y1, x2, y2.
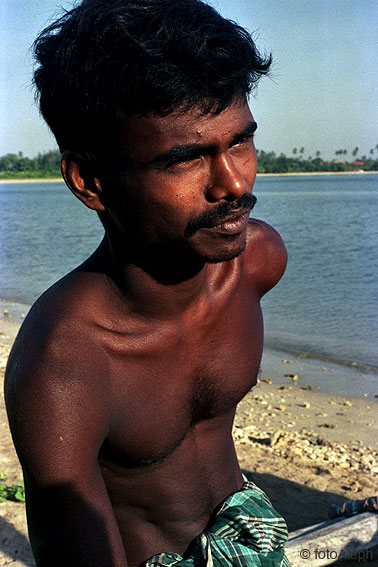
(242, 219, 287, 296)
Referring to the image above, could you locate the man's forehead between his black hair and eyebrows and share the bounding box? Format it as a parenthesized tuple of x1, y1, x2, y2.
(117, 101, 253, 161)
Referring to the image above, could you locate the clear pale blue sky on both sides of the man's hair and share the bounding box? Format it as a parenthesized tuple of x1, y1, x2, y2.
(0, 0, 378, 159)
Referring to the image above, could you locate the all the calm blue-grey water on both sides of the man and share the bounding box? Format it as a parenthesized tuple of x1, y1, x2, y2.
(0, 175, 378, 367)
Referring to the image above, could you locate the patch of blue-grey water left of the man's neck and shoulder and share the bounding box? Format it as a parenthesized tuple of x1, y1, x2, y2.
(0, 182, 104, 304)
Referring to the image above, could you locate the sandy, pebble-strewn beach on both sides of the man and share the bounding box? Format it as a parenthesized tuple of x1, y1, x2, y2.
(0, 308, 378, 567)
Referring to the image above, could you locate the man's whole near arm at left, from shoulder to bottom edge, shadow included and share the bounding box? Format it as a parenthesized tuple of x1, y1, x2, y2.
(5, 273, 126, 565)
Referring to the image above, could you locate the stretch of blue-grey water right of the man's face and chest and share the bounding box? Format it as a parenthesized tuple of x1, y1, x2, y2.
(254, 175, 378, 366)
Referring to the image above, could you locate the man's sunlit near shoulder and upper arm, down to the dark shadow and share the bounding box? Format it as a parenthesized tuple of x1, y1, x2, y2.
(5, 276, 111, 482)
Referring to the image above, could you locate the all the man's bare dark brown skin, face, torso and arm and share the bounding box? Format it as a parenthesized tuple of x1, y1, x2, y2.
(6, 101, 286, 567)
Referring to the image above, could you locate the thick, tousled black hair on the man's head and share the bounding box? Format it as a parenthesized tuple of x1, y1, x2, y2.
(34, 0, 271, 153)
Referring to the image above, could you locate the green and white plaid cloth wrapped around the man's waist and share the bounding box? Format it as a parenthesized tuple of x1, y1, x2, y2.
(146, 481, 290, 567)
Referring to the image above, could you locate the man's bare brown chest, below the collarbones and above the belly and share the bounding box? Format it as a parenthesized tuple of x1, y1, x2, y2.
(100, 290, 263, 467)
